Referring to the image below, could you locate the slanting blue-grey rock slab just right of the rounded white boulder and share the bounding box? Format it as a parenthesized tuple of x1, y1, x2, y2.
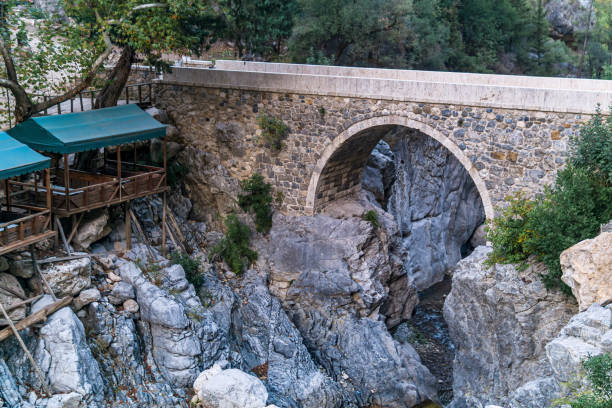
(232, 271, 343, 408)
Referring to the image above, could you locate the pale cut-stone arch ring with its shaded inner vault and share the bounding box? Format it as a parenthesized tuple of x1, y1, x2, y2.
(306, 115, 495, 219)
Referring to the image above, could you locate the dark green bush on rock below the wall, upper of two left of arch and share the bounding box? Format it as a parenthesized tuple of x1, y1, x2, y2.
(238, 174, 272, 233)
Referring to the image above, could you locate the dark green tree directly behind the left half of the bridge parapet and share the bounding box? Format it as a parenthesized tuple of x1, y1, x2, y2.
(219, 0, 297, 58)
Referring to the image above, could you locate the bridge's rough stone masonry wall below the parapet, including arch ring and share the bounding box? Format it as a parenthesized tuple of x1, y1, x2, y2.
(155, 82, 590, 216)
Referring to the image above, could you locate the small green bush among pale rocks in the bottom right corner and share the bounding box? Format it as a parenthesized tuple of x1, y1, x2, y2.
(560, 353, 612, 408)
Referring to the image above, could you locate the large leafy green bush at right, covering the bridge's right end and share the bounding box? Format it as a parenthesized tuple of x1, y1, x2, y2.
(488, 108, 612, 293)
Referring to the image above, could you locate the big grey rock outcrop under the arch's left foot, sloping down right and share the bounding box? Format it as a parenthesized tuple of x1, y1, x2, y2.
(260, 215, 436, 407)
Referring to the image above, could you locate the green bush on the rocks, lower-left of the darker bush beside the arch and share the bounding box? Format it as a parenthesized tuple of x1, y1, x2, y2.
(211, 214, 257, 275)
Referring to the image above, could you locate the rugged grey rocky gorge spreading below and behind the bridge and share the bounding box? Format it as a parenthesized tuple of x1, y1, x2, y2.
(0, 106, 612, 408)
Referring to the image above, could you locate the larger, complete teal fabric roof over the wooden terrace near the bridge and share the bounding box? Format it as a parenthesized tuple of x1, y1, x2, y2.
(8, 104, 166, 154)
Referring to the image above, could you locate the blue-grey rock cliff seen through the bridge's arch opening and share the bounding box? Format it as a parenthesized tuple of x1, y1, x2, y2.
(378, 128, 485, 290)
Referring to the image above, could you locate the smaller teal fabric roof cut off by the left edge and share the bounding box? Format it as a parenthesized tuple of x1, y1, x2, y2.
(0, 132, 51, 180)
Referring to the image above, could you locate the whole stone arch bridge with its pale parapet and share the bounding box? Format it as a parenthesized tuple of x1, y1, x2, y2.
(155, 60, 612, 218)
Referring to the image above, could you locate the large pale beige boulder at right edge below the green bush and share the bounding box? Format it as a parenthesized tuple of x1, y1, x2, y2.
(560, 232, 612, 311)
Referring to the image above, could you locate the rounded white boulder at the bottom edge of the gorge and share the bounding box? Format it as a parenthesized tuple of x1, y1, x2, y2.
(194, 366, 268, 408)
